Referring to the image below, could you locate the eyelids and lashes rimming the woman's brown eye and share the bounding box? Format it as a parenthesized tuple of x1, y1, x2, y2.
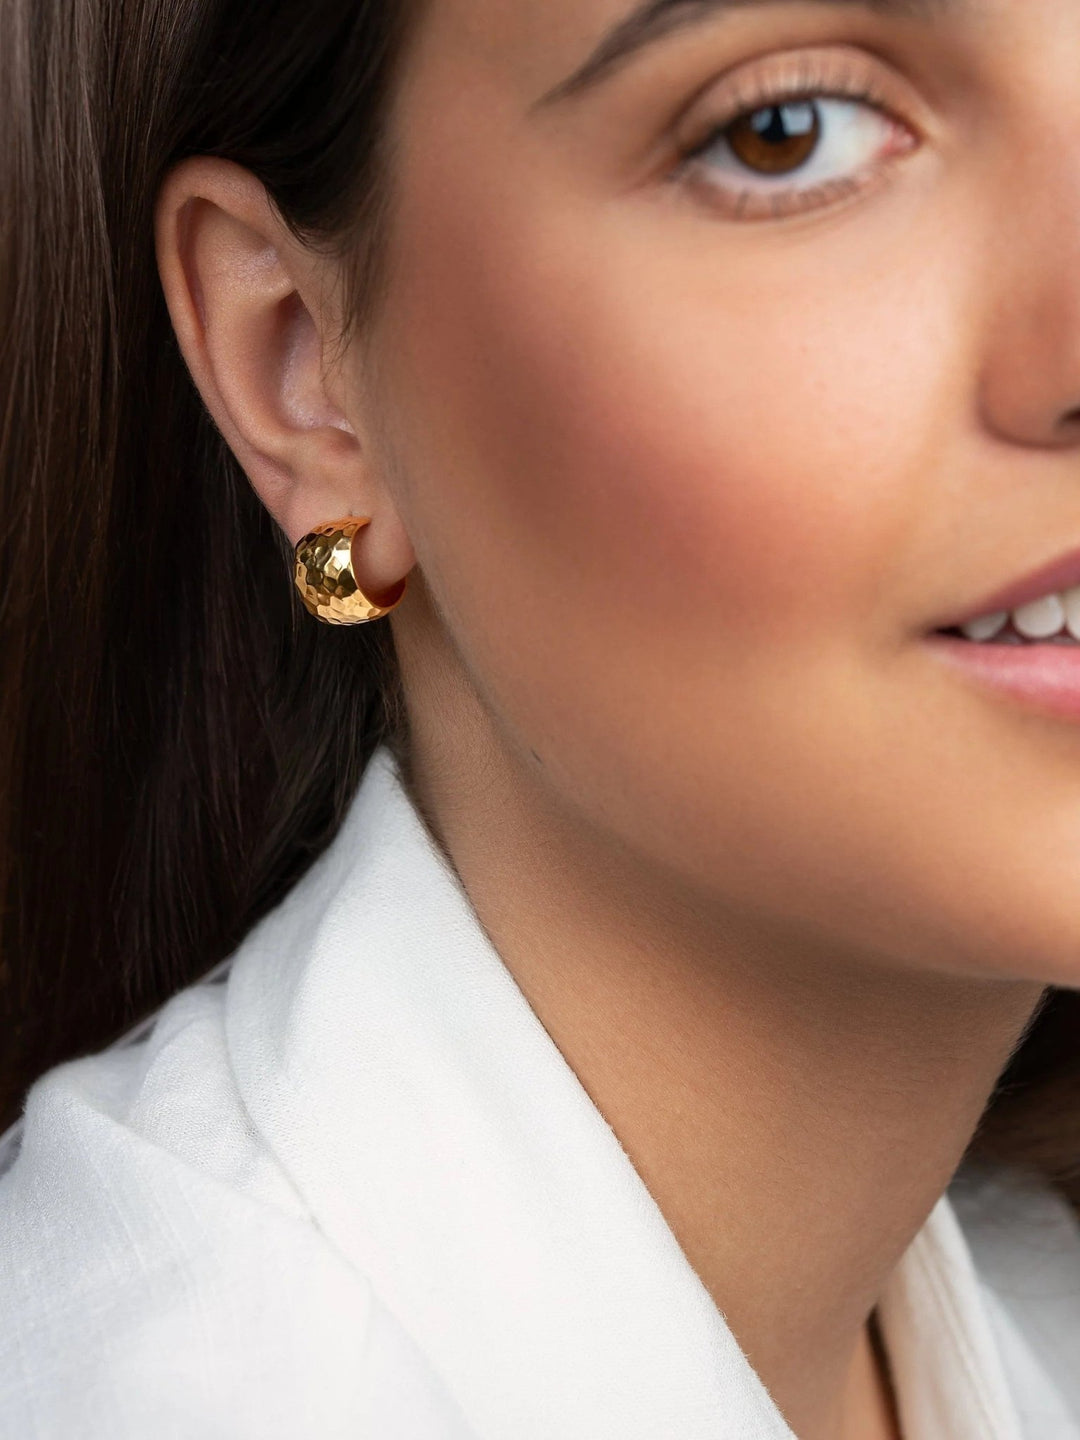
(672, 56, 912, 219)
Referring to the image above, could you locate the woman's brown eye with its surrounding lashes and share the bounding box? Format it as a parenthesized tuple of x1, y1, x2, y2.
(675, 53, 914, 219)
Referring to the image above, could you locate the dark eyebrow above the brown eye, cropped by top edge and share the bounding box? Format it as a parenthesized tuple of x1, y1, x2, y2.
(530, 0, 960, 109)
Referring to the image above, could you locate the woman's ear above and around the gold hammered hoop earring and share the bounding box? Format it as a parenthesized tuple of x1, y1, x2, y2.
(154, 156, 416, 599)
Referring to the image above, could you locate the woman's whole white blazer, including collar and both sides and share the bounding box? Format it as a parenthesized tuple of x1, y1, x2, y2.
(0, 747, 1080, 1440)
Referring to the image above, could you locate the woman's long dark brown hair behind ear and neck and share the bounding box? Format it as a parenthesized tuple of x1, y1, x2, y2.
(0, 0, 1080, 1205)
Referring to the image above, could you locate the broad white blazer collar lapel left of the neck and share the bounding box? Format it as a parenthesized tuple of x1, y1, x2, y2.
(226, 746, 1019, 1440)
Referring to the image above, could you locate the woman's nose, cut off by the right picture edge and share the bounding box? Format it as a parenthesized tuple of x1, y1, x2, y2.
(975, 64, 1080, 446)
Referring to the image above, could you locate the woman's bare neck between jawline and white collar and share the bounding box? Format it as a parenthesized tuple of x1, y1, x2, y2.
(403, 682, 1043, 1440)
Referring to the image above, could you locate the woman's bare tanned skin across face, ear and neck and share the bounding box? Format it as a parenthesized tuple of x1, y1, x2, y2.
(157, 0, 1080, 1440)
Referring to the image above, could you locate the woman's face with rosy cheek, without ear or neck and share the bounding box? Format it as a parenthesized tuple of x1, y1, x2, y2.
(351, 0, 1080, 985)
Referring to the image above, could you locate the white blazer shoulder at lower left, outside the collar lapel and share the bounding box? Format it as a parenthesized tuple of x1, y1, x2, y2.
(0, 982, 472, 1440)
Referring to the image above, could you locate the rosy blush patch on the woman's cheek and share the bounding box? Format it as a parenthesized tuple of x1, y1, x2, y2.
(460, 304, 858, 659)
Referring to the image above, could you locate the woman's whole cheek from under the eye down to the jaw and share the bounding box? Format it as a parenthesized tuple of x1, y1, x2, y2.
(377, 92, 979, 863)
